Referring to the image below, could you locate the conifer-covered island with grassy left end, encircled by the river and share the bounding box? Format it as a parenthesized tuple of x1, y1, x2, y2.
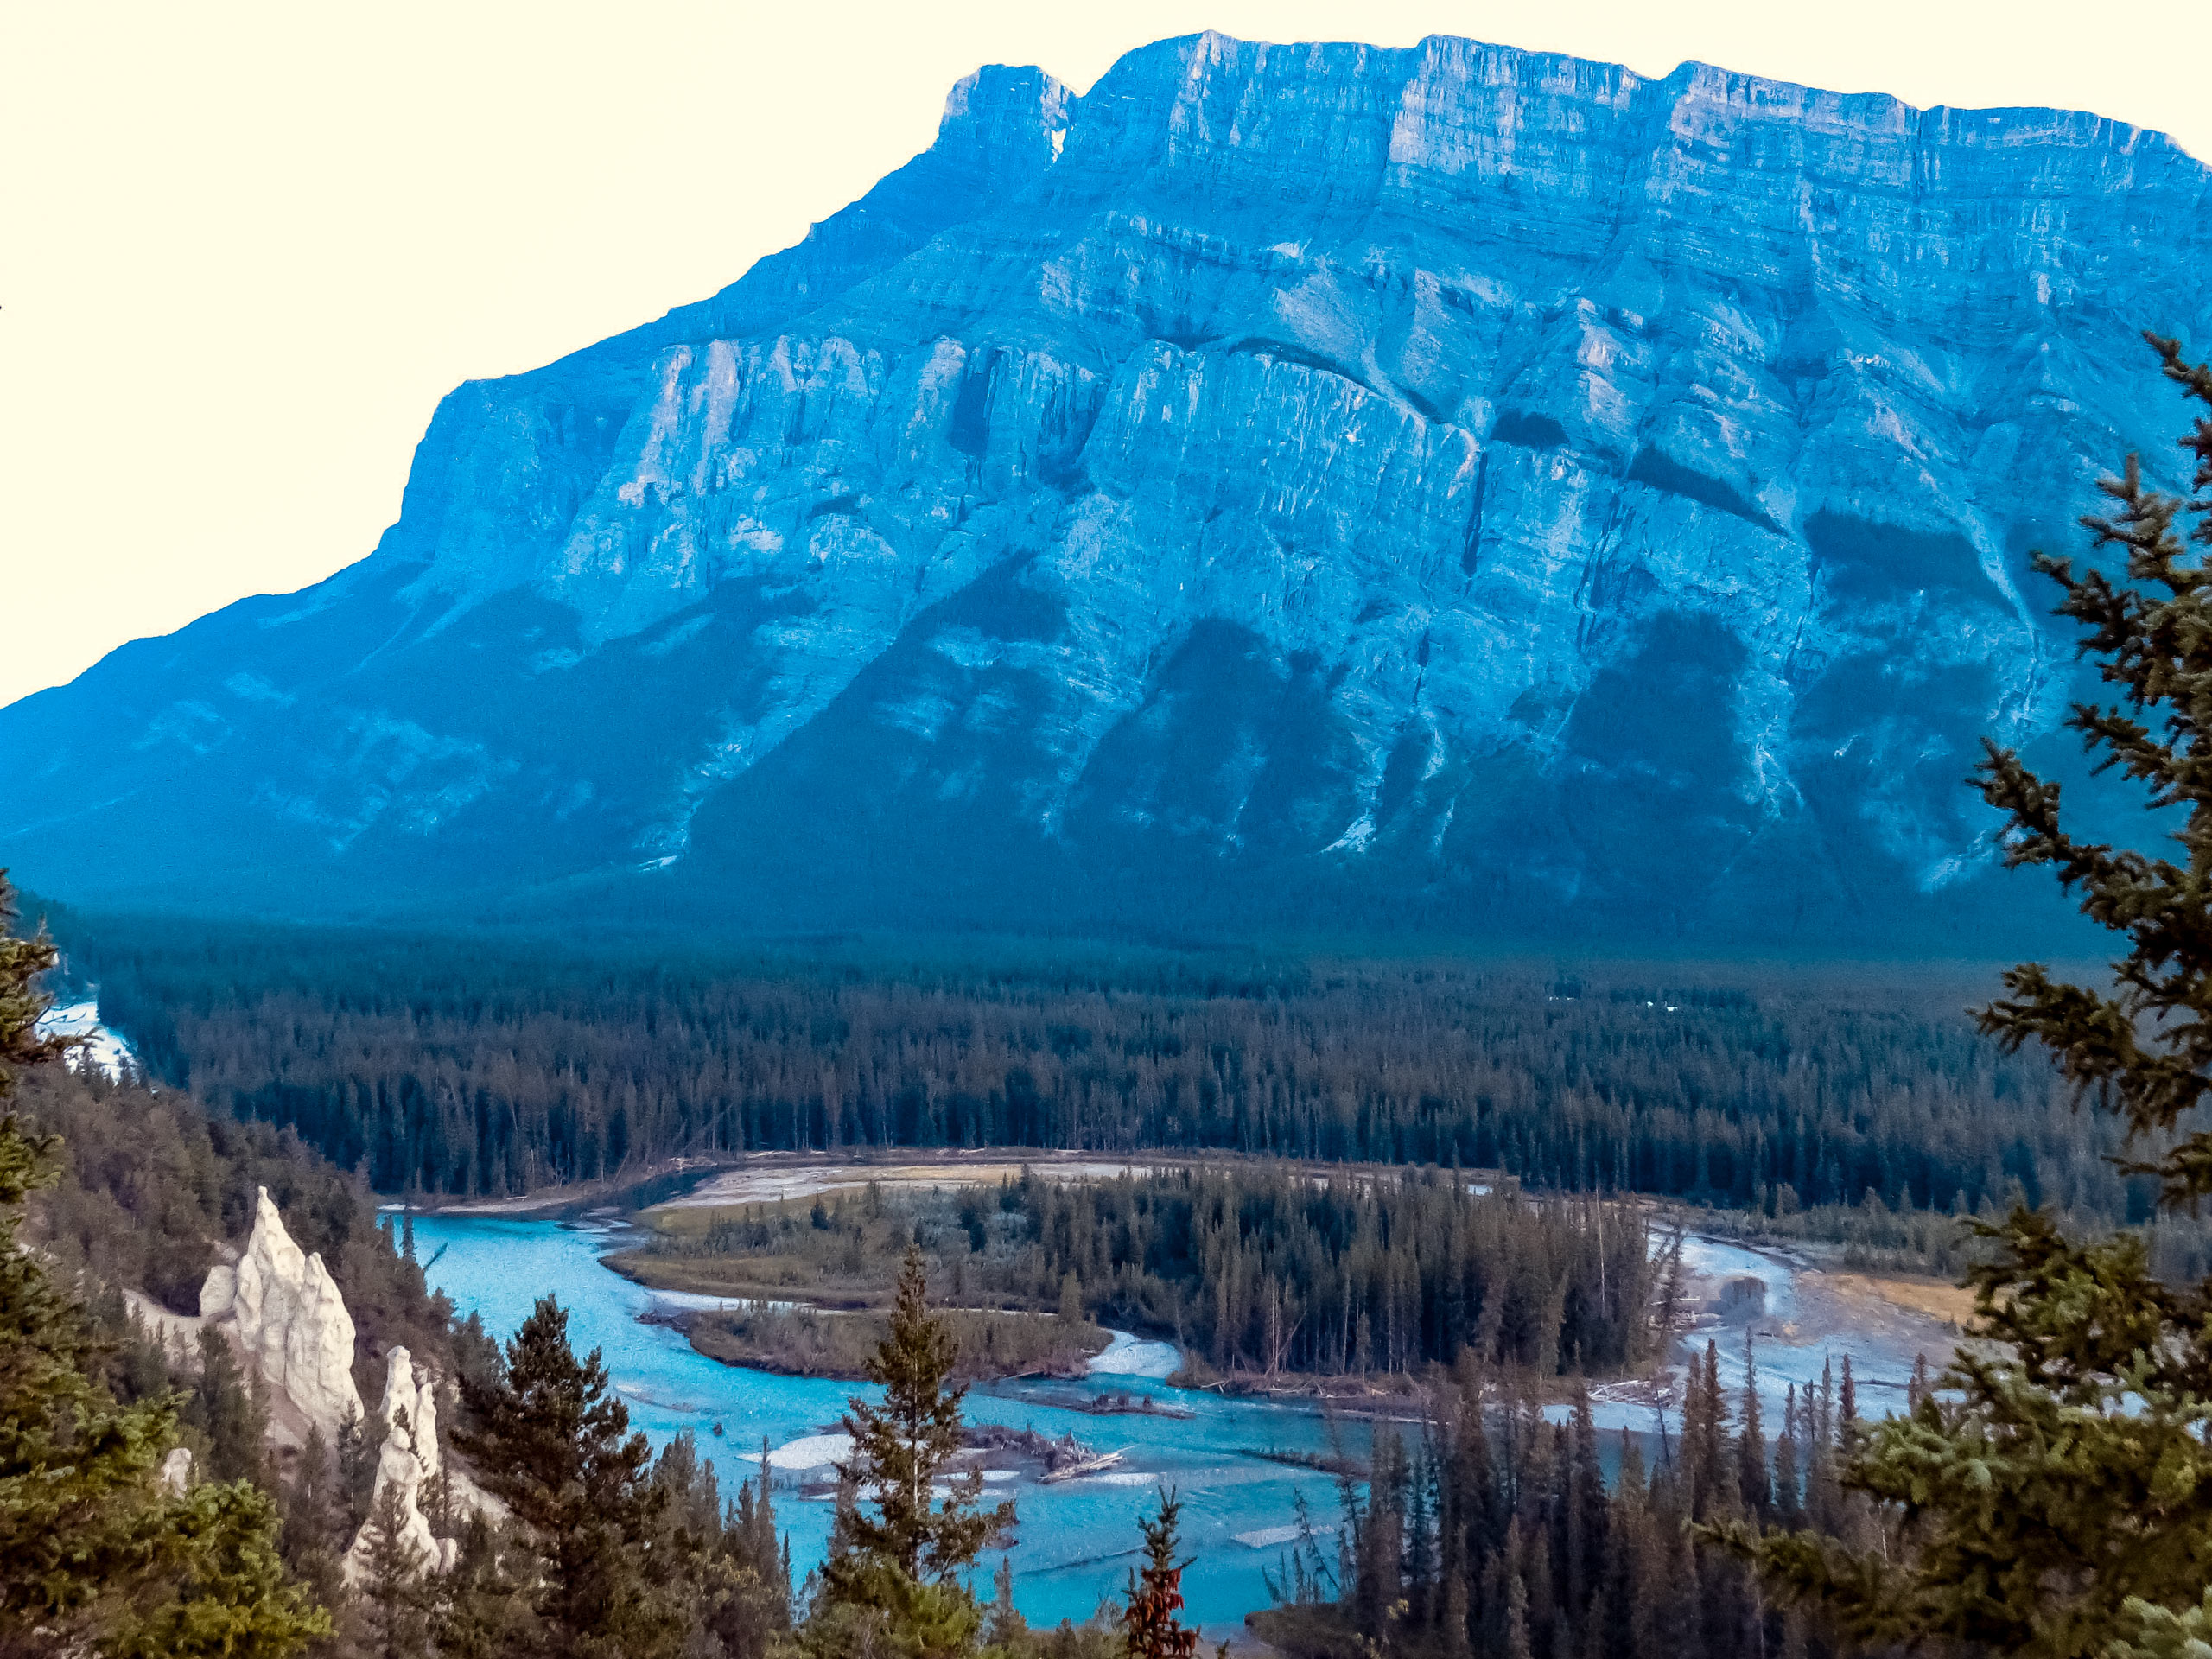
(613, 1164, 1666, 1380)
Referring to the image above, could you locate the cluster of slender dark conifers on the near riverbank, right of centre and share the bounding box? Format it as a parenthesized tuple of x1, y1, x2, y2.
(1252, 1347, 1885, 1659)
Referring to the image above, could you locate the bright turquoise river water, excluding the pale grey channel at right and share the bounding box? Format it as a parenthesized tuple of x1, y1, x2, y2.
(416, 1217, 1370, 1635)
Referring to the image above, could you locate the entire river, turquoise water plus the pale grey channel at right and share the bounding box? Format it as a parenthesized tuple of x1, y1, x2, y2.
(416, 1214, 1955, 1632)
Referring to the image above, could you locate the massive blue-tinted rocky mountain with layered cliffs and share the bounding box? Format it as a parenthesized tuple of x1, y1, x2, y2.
(0, 35, 2212, 947)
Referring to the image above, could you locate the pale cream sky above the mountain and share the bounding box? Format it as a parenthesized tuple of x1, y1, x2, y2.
(13, 0, 2212, 703)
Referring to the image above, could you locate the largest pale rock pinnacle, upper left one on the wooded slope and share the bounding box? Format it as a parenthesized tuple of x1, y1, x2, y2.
(199, 1188, 363, 1445)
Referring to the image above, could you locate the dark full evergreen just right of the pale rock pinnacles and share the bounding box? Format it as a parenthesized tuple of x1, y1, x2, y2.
(454, 1296, 683, 1659)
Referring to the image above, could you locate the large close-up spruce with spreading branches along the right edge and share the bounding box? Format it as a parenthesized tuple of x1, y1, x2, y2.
(1734, 336, 2212, 1659)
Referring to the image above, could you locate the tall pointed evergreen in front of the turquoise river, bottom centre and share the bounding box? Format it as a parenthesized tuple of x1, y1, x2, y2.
(805, 1245, 1013, 1656)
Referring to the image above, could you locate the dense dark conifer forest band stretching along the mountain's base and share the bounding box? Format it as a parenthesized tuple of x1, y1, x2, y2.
(39, 913, 2152, 1224)
